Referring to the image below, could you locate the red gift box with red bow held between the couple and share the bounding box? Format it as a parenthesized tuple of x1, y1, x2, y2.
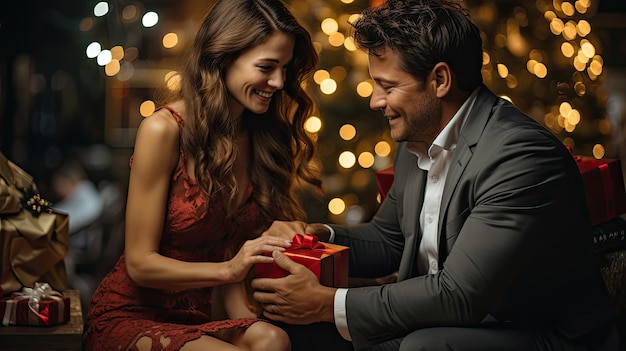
(254, 234, 349, 288)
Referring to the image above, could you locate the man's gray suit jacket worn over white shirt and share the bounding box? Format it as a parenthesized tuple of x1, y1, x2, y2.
(333, 87, 614, 349)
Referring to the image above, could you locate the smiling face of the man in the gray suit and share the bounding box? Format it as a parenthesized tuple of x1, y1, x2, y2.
(369, 49, 443, 145)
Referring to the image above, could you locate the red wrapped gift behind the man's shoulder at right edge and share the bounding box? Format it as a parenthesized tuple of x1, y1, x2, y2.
(574, 156, 626, 225)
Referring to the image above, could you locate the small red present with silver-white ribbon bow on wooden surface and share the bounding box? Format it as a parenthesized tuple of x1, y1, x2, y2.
(0, 283, 70, 327)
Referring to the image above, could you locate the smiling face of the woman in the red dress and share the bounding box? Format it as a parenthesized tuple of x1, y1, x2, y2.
(225, 32, 295, 115)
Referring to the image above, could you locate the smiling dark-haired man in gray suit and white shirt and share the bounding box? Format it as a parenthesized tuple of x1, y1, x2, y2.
(253, 0, 617, 351)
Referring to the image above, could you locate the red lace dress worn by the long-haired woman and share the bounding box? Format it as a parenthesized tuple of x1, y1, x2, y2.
(83, 108, 259, 351)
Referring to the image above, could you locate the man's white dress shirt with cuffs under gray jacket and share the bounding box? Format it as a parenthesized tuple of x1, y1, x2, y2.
(327, 89, 478, 340)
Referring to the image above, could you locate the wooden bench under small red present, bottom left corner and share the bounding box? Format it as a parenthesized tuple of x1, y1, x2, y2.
(0, 290, 83, 351)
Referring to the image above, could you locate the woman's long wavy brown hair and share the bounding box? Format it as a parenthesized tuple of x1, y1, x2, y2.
(158, 0, 321, 224)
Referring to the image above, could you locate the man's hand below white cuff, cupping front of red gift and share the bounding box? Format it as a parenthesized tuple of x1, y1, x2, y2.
(252, 251, 336, 324)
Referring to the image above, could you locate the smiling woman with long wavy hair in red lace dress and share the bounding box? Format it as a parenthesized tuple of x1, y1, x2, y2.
(84, 0, 321, 351)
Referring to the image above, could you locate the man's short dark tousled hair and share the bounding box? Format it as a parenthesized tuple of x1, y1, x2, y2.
(352, 0, 482, 91)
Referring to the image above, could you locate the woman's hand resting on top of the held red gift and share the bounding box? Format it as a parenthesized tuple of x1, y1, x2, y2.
(226, 236, 291, 282)
